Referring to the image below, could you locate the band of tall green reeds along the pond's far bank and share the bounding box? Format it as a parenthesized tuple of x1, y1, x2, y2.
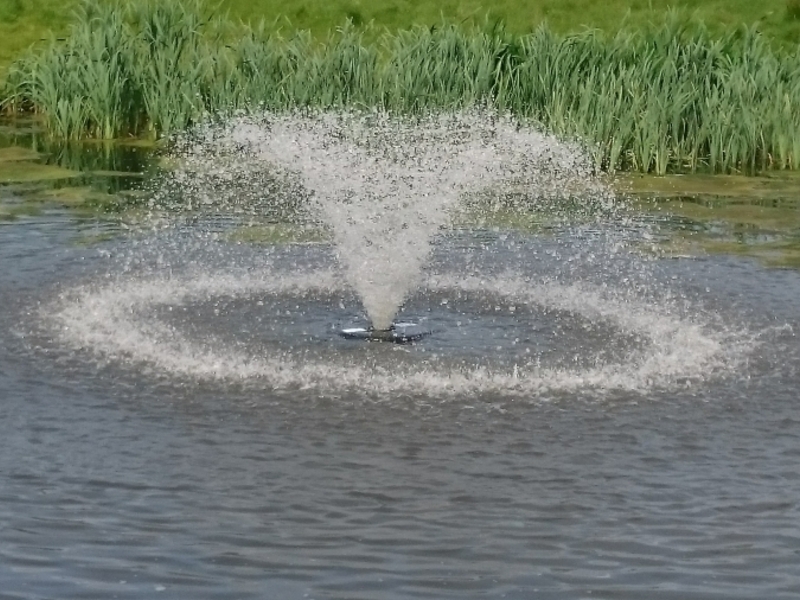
(0, 0, 800, 174)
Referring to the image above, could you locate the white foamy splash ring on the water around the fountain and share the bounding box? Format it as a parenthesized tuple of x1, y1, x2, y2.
(50, 269, 746, 398)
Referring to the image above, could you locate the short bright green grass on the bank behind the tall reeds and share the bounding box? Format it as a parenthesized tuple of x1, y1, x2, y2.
(0, 0, 800, 78)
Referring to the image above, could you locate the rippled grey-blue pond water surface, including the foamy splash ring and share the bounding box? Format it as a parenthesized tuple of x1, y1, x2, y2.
(0, 209, 800, 599)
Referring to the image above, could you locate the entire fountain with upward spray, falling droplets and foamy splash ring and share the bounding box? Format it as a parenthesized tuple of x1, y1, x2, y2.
(51, 111, 743, 396)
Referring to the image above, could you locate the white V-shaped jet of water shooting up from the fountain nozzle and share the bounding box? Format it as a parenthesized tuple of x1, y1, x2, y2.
(169, 112, 602, 329)
